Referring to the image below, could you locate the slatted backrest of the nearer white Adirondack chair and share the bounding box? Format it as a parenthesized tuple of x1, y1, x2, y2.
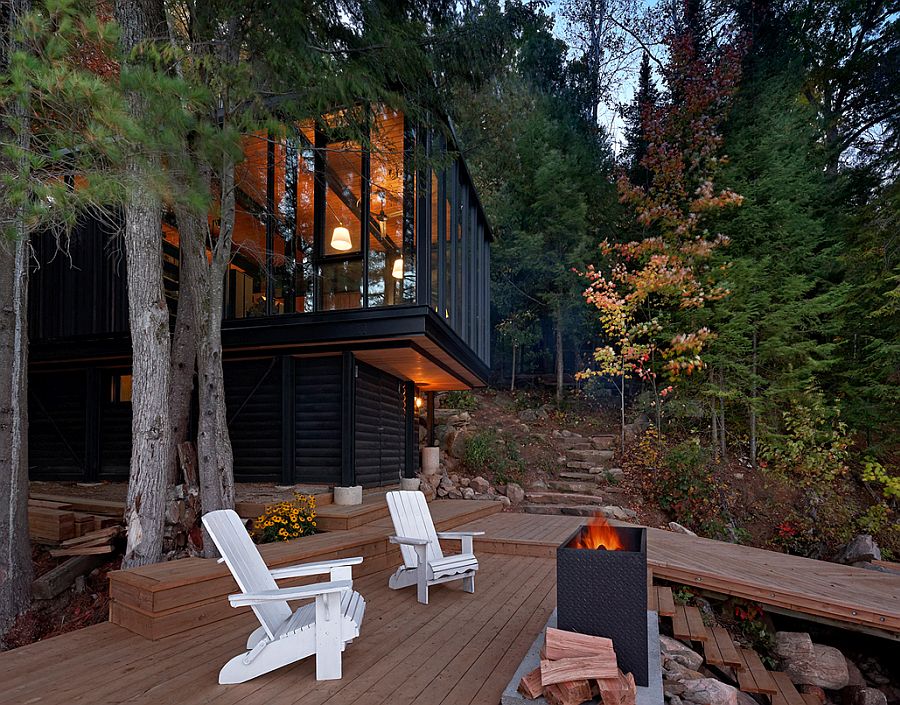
(203, 509, 291, 638)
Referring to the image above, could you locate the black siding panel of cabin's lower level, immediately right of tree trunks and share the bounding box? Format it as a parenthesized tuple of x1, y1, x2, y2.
(224, 358, 281, 482)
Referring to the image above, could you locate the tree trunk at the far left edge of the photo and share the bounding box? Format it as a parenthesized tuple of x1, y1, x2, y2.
(0, 0, 33, 638)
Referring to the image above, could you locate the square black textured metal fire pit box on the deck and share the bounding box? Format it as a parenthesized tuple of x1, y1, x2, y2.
(556, 526, 648, 686)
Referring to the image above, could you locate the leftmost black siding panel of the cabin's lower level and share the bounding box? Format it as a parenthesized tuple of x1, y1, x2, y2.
(28, 370, 86, 479)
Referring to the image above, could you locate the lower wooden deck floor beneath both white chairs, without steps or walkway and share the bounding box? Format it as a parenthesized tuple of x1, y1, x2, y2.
(0, 555, 556, 705)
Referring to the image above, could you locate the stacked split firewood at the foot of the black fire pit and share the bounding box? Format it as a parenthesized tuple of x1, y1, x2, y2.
(519, 627, 637, 705)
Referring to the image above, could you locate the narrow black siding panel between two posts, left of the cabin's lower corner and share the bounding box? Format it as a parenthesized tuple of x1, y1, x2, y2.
(294, 356, 341, 484)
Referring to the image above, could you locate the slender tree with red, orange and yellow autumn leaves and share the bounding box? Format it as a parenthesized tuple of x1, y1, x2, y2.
(582, 11, 742, 442)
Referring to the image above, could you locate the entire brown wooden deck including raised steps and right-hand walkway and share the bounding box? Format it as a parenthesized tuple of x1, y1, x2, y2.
(0, 501, 900, 705)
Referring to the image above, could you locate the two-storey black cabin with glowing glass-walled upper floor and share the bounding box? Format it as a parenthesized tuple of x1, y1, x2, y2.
(29, 109, 491, 486)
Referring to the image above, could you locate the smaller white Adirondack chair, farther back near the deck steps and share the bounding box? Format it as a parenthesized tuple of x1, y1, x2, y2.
(387, 491, 484, 605)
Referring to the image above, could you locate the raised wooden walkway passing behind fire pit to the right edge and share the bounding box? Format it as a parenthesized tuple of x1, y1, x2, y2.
(459, 514, 900, 638)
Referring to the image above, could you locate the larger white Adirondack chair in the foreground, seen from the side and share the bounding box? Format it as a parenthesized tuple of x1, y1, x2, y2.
(203, 509, 366, 684)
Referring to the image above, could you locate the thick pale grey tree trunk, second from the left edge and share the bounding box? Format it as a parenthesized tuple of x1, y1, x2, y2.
(116, 0, 171, 568)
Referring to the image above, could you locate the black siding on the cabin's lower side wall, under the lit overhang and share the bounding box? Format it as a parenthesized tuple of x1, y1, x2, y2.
(355, 363, 406, 487)
